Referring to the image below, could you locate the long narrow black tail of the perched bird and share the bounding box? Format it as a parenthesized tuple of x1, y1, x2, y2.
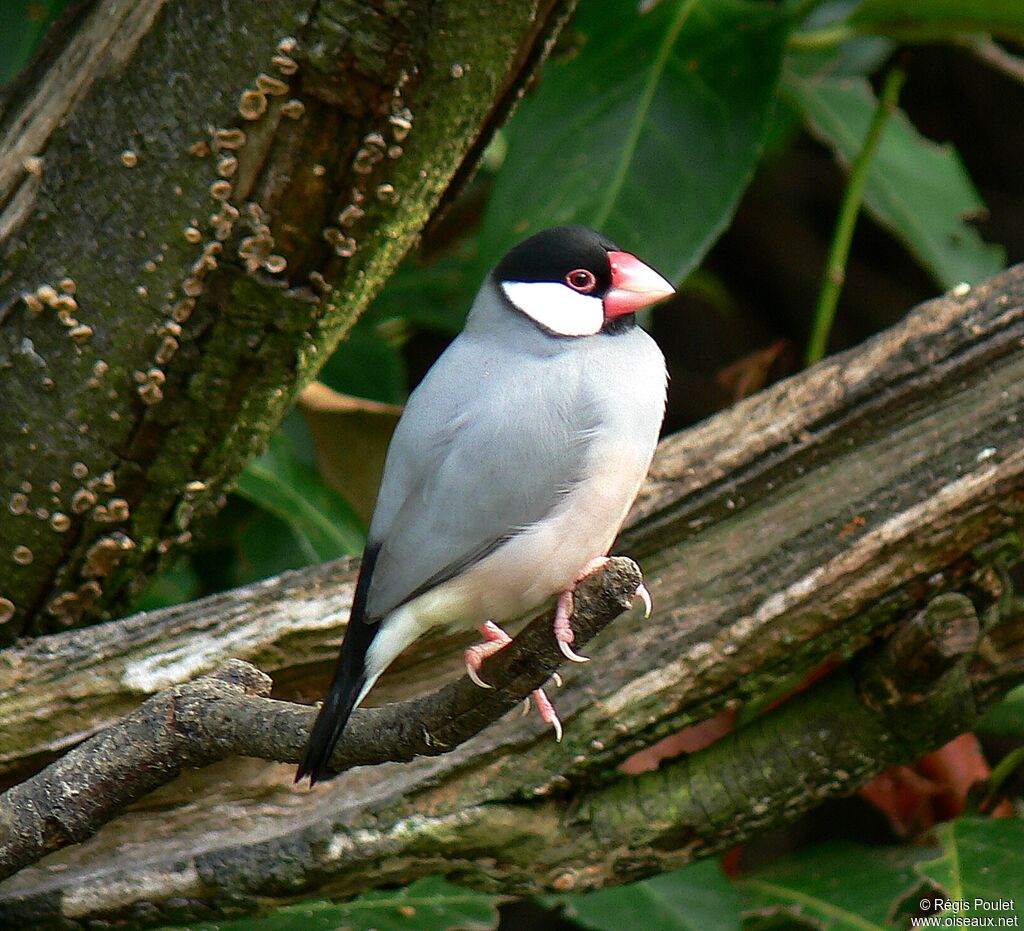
(295, 545, 380, 786)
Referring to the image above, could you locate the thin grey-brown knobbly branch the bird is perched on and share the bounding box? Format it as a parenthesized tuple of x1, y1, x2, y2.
(0, 558, 641, 879)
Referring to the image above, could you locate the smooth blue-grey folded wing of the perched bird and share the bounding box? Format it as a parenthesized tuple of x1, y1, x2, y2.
(367, 334, 593, 621)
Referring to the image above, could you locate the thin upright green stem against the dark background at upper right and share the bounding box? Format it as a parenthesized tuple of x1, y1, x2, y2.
(806, 68, 906, 366)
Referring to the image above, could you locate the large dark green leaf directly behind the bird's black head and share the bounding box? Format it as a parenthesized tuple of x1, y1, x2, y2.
(480, 0, 791, 281)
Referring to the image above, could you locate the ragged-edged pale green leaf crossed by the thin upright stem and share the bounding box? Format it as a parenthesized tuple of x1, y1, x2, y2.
(783, 72, 1006, 288)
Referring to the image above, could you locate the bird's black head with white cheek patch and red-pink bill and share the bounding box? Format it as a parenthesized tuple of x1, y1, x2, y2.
(494, 226, 674, 337)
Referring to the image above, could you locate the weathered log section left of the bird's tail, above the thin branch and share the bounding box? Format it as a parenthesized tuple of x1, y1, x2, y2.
(0, 560, 354, 772)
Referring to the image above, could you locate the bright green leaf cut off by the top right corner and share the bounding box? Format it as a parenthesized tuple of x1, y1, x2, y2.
(847, 0, 1024, 41)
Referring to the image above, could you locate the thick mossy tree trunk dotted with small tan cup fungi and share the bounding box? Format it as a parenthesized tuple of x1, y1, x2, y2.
(0, 0, 571, 643)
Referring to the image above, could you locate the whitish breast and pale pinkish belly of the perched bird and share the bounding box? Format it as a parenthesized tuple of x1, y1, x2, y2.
(360, 328, 667, 701)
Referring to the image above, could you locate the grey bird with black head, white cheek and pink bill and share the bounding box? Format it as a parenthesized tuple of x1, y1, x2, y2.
(296, 226, 674, 784)
